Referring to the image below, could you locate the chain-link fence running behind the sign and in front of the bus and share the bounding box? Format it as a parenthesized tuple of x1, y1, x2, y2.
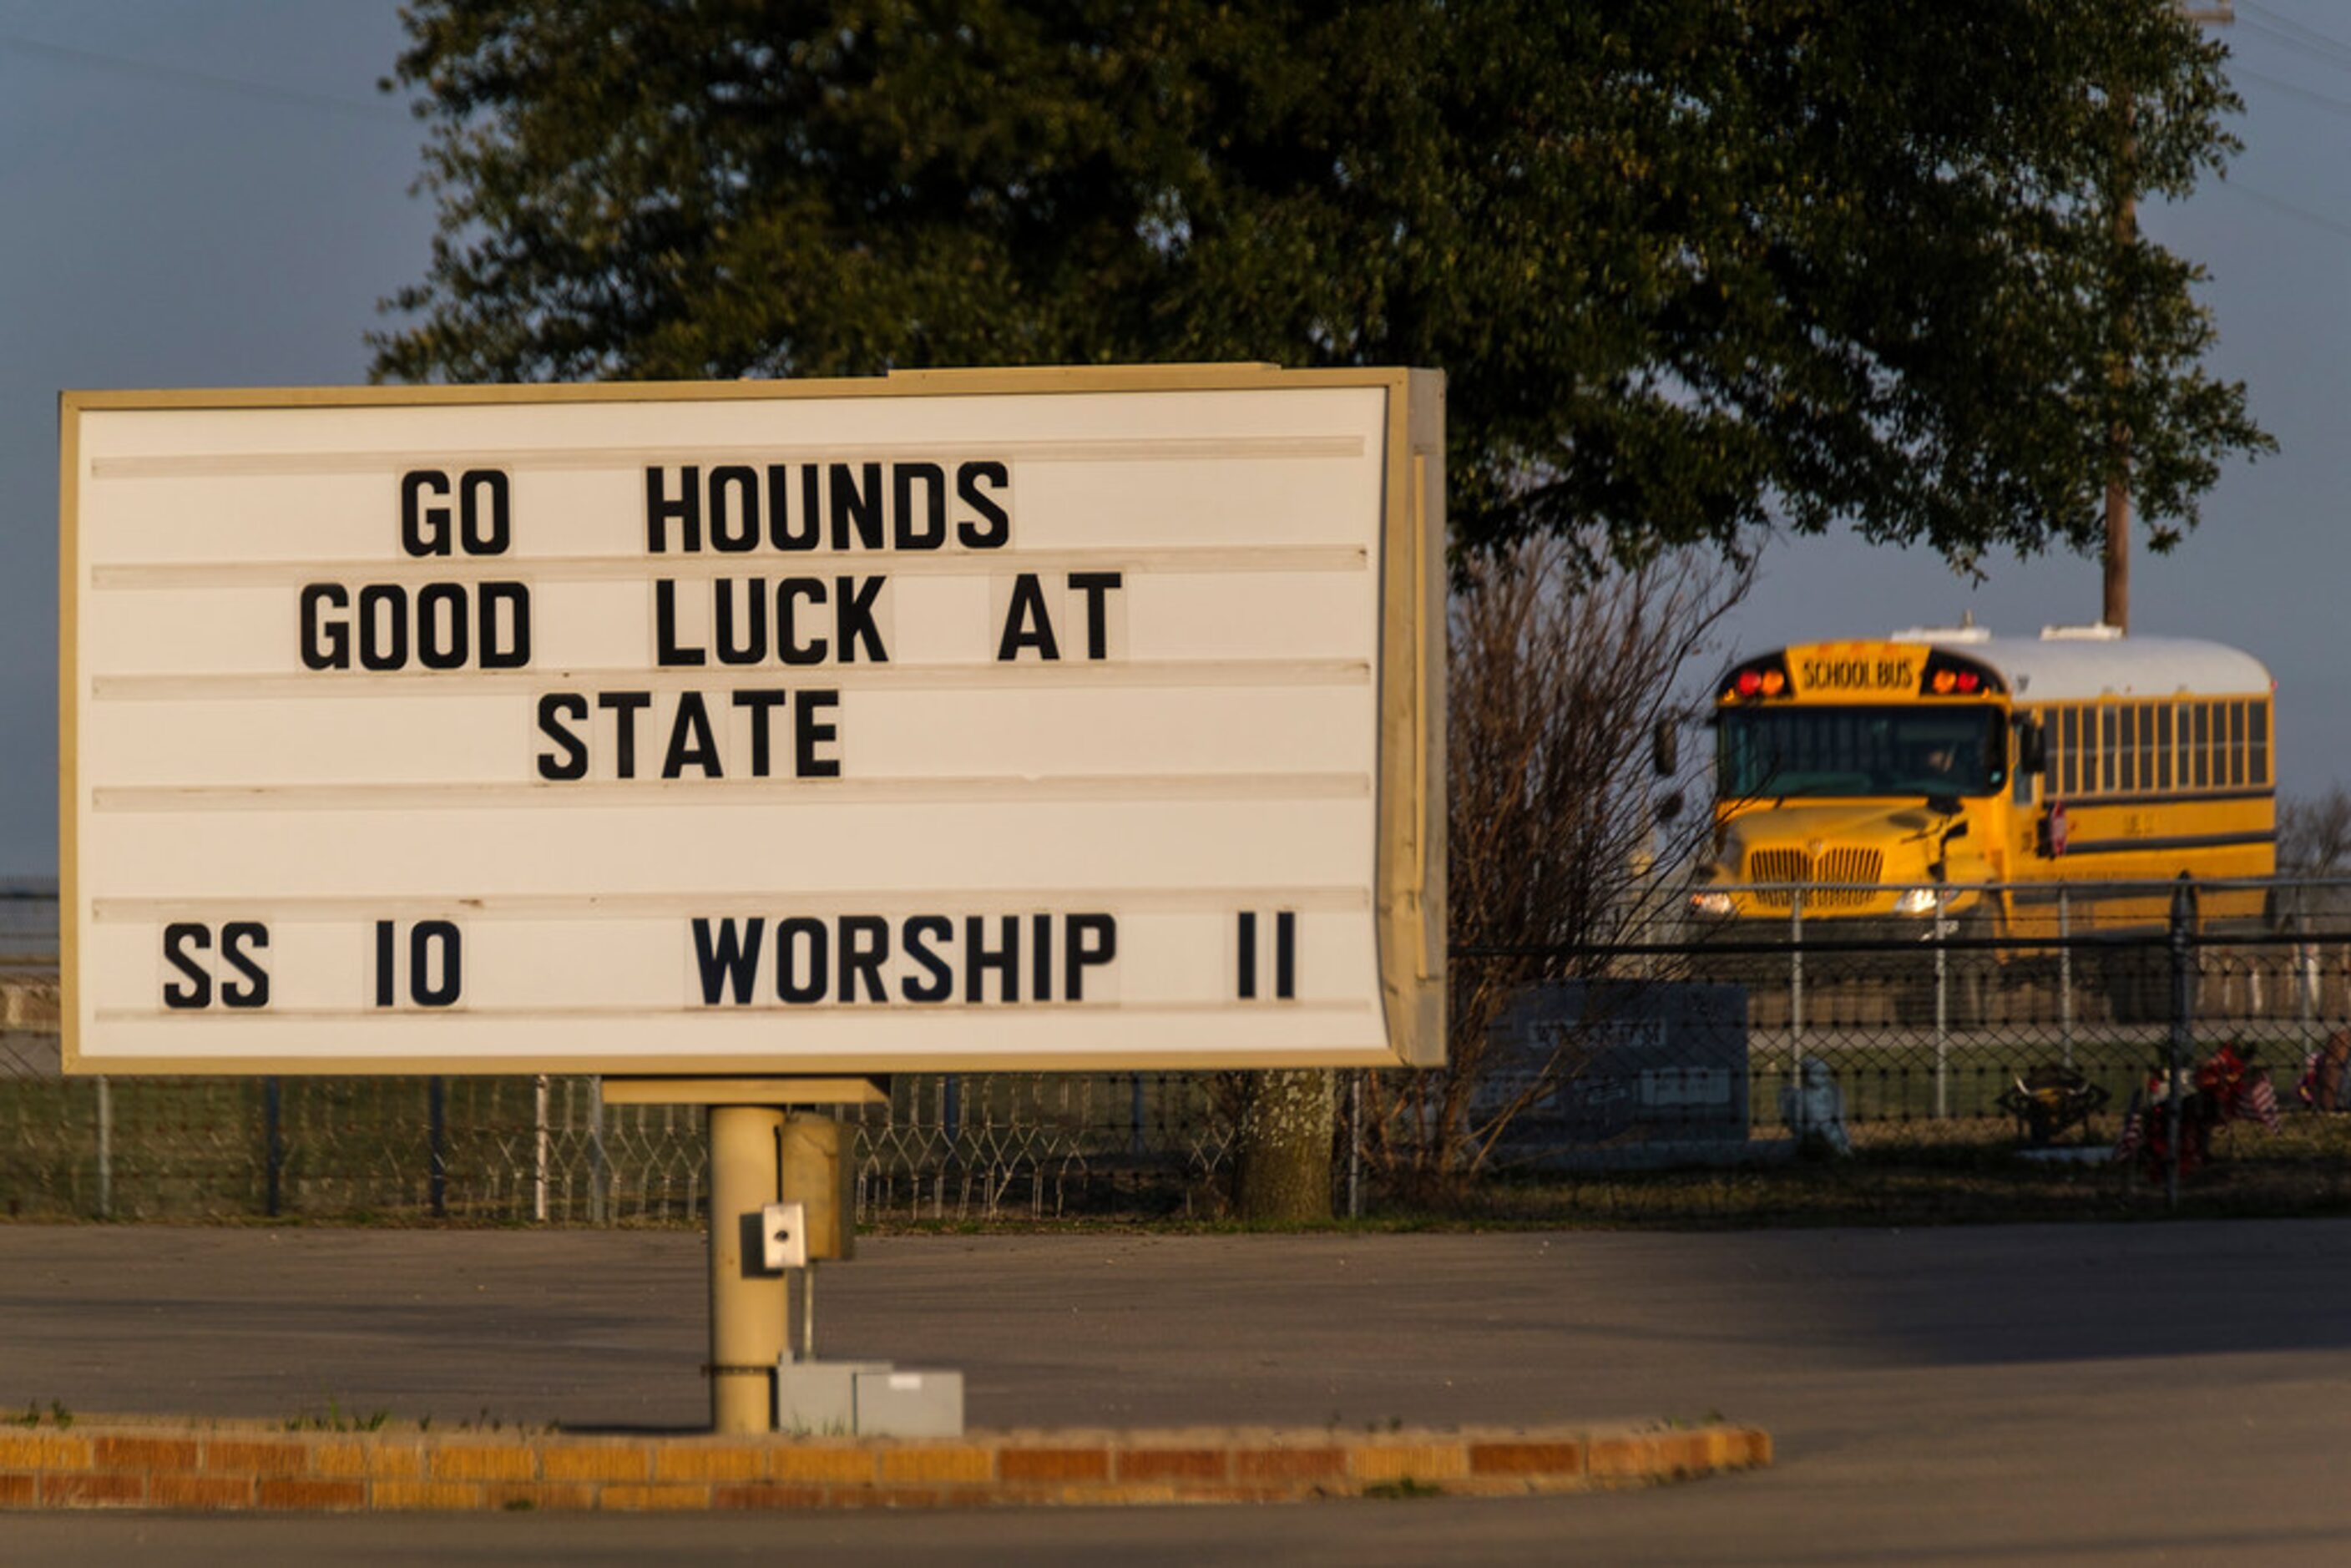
(13, 882, 2351, 1222)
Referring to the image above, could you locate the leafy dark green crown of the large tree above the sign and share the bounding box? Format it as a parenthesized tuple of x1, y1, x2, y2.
(377, 0, 2267, 564)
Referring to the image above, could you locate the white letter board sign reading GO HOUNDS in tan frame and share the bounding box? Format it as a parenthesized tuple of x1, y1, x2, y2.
(61, 367, 1443, 1075)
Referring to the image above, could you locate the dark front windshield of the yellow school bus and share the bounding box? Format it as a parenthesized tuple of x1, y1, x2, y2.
(1716, 706, 2008, 799)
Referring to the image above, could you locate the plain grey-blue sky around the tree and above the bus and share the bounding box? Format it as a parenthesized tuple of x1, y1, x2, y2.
(13, 0, 2351, 877)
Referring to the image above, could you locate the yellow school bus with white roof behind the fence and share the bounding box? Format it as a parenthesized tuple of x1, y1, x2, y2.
(1691, 625, 2278, 936)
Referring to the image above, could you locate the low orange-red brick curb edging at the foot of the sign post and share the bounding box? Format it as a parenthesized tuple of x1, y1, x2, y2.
(0, 1420, 1770, 1511)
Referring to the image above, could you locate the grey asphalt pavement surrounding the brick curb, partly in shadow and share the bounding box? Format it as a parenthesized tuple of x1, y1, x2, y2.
(0, 1220, 2351, 1568)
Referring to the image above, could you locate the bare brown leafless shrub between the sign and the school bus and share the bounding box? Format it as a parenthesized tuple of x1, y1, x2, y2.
(1366, 539, 1752, 1199)
